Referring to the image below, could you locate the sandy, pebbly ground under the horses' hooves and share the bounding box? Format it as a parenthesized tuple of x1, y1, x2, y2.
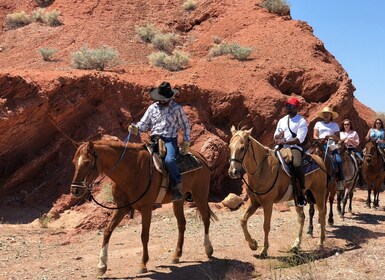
(0, 190, 385, 280)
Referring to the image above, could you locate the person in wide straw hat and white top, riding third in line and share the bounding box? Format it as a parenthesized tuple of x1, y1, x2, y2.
(313, 106, 345, 191)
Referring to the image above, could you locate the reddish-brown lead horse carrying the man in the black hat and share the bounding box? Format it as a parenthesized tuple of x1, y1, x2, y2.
(71, 141, 217, 275)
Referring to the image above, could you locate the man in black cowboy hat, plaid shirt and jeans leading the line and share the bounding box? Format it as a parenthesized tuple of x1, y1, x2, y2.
(128, 82, 191, 202)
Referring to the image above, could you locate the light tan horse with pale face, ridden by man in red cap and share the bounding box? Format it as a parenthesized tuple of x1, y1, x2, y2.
(228, 126, 327, 257)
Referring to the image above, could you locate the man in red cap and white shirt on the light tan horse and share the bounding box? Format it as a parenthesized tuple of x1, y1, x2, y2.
(274, 97, 308, 207)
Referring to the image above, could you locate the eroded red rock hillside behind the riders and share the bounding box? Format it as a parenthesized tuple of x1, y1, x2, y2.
(0, 0, 374, 215)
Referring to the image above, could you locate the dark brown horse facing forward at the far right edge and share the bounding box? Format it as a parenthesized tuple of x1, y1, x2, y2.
(362, 140, 385, 208)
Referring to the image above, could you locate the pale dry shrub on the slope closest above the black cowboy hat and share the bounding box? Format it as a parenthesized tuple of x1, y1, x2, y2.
(148, 51, 190, 71)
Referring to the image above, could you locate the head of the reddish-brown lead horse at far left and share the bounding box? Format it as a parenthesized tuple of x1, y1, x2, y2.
(70, 142, 99, 197)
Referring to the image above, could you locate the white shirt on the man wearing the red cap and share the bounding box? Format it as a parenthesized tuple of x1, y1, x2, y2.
(274, 114, 308, 150)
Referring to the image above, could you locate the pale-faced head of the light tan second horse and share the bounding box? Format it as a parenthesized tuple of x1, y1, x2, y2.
(228, 126, 252, 179)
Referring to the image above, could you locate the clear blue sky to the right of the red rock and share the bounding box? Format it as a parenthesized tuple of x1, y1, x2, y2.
(286, 0, 385, 112)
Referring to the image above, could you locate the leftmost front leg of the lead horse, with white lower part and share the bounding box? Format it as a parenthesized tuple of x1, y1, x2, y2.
(98, 209, 127, 276)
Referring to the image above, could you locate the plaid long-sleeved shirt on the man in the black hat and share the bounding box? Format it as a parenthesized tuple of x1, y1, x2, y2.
(136, 100, 191, 141)
